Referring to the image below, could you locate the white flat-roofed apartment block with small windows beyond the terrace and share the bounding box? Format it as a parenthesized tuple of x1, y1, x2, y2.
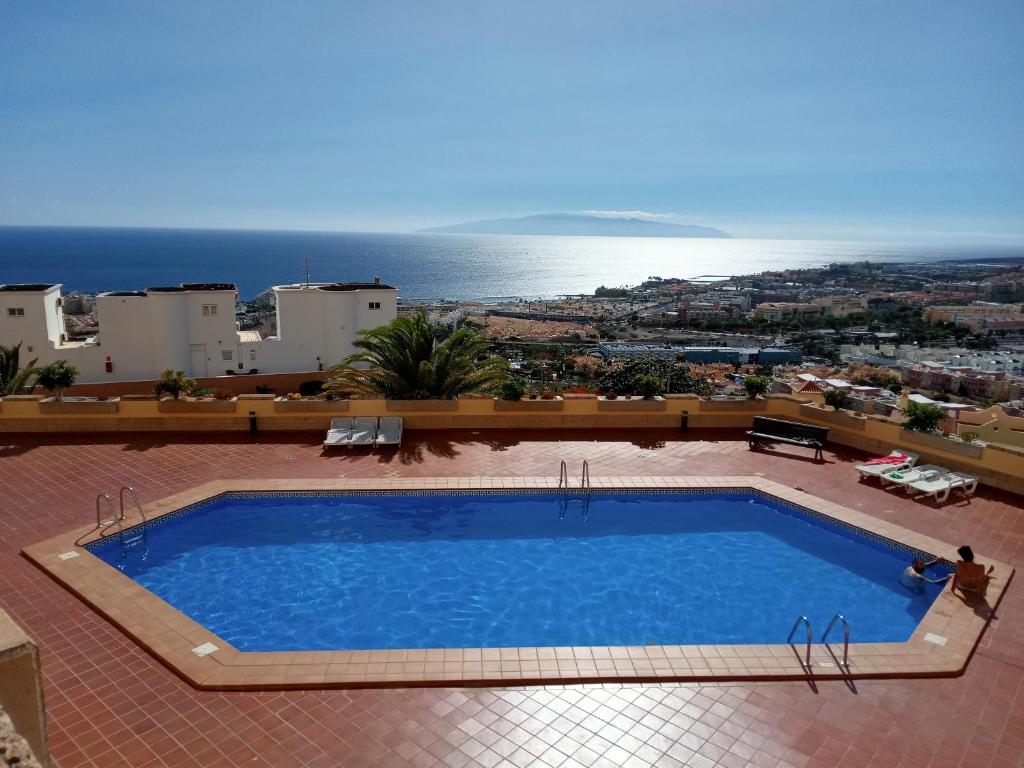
(0, 279, 398, 383)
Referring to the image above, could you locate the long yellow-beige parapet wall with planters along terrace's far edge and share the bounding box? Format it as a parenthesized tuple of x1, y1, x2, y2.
(0, 395, 1024, 494)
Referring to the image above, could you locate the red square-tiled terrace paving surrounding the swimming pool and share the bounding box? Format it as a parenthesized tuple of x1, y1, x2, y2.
(0, 430, 1024, 768)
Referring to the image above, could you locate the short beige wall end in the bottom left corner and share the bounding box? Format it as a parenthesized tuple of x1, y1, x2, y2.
(0, 610, 49, 768)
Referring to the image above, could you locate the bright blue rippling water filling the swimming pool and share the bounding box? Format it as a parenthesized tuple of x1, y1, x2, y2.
(91, 493, 940, 651)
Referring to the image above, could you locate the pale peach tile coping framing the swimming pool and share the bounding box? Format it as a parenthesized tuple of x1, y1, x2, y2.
(24, 476, 1014, 690)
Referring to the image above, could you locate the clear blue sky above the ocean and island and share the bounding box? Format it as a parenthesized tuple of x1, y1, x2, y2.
(0, 0, 1024, 242)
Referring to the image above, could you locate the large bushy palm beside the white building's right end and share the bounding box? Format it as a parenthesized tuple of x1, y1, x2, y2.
(329, 310, 506, 400)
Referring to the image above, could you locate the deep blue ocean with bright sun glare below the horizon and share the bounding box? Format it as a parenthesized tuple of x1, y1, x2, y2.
(0, 226, 1024, 300)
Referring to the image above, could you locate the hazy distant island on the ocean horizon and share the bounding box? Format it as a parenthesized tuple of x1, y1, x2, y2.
(419, 213, 732, 238)
